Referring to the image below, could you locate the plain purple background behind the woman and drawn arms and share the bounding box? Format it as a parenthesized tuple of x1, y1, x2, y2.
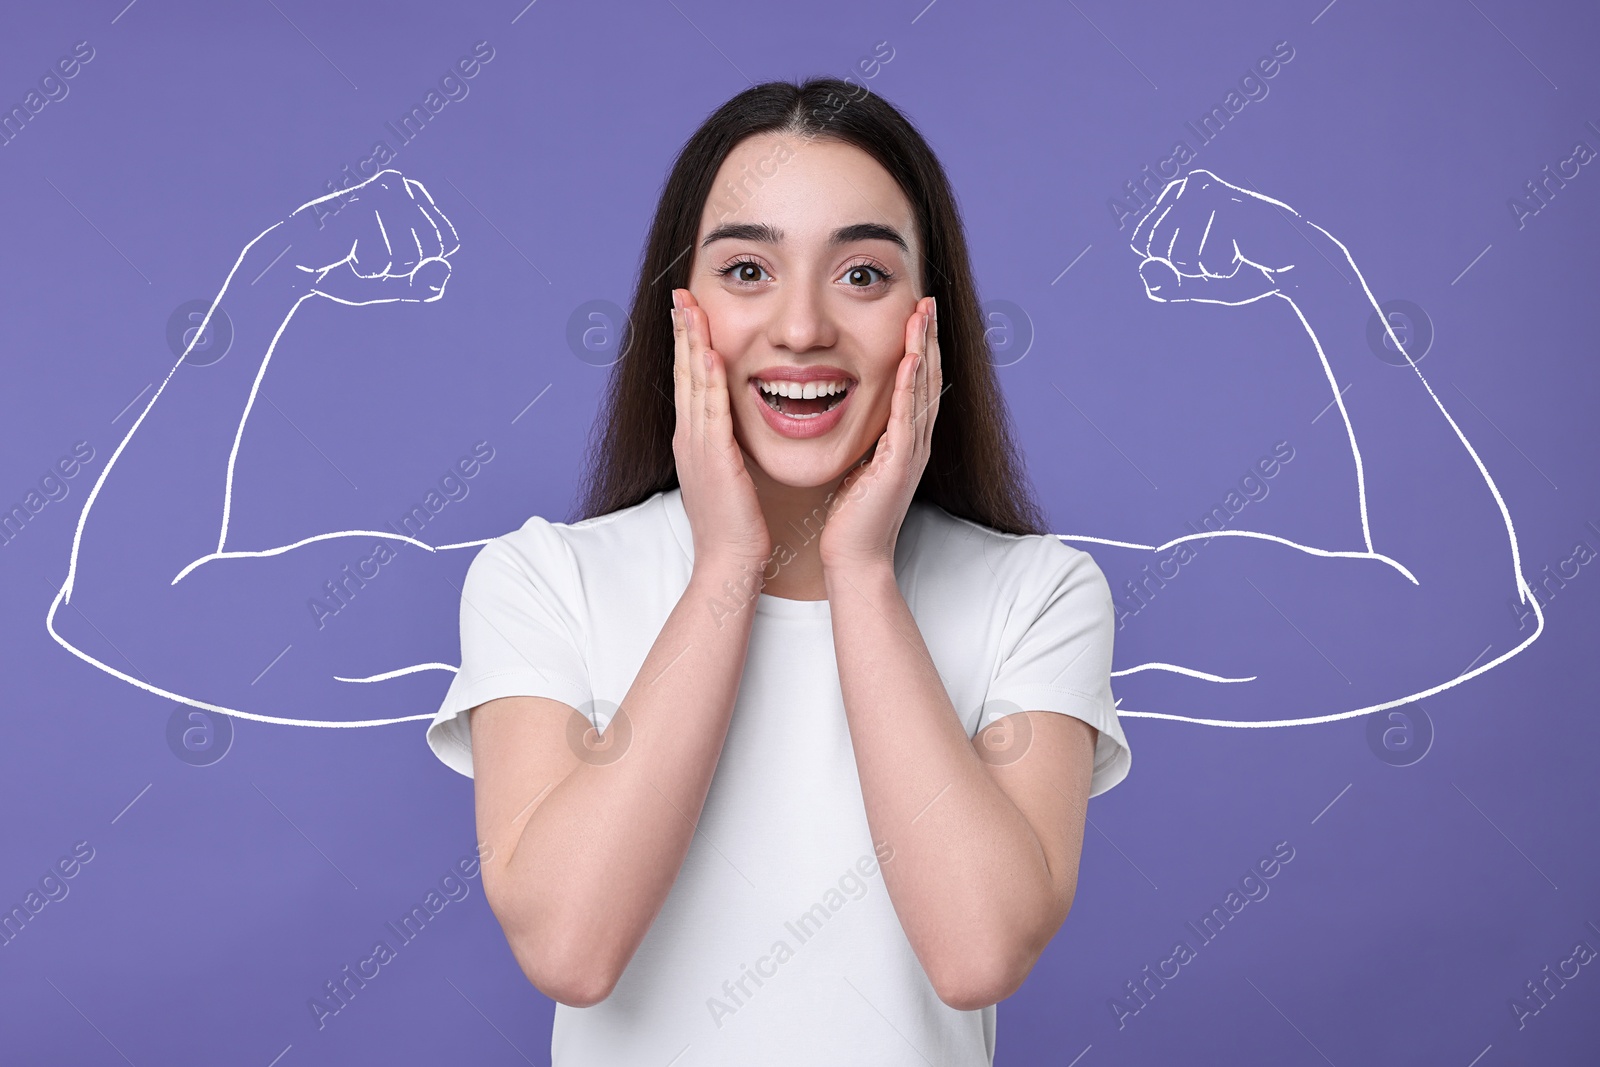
(0, 0, 1600, 1067)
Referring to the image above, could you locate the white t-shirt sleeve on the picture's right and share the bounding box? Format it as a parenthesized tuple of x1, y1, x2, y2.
(978, 537, 1133, 797)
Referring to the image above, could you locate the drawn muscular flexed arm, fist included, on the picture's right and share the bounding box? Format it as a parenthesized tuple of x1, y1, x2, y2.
(1088, 170, 1542, 726)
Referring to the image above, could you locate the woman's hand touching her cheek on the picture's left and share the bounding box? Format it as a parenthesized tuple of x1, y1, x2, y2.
(672, 290, 773, 568)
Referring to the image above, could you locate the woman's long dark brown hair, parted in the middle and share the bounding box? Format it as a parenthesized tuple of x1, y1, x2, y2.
(579, 78, 1046, 534)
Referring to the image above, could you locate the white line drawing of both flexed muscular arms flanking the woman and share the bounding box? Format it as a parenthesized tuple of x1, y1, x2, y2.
(45, 170, 1544, 728)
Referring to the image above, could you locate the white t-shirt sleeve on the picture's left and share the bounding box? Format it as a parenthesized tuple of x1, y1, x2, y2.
(427, 518, 592, 777)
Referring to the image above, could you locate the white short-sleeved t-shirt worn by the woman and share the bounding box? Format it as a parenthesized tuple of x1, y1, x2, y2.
(427, 490, 1130, 1067)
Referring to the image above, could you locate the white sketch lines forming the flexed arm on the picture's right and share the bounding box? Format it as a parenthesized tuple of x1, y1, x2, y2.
(1056, 168, 1544, 728)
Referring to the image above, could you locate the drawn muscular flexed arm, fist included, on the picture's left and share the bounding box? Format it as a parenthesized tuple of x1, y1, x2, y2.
(45, 171, 459, 726)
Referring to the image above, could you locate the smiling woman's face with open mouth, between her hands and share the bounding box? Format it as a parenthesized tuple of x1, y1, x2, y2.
(688, 134, 923, 488)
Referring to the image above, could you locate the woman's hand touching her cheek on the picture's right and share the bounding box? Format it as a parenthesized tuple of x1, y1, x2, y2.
(819, 296, 944, 571)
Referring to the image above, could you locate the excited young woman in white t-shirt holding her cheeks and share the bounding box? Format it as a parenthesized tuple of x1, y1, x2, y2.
(427, 78, 1130, 1067)
